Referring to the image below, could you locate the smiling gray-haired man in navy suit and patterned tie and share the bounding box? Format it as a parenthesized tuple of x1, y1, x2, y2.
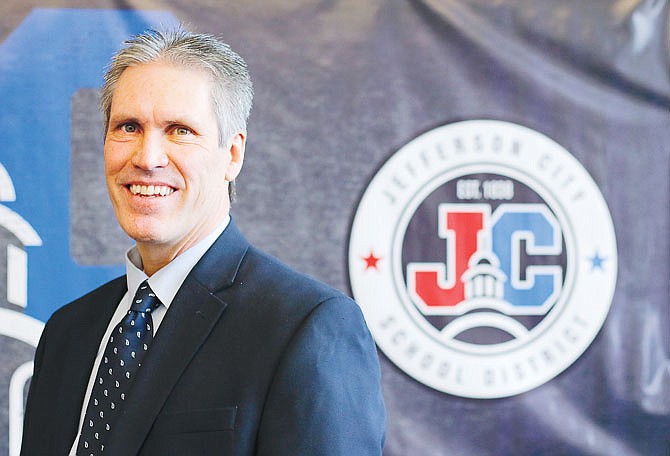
(21, 30, 385, 456)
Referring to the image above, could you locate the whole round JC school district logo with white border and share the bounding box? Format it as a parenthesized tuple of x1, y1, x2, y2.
(349, 120, 617, 398)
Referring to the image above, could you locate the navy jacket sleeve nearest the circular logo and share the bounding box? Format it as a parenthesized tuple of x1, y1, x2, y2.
(258, 297, 386, 456)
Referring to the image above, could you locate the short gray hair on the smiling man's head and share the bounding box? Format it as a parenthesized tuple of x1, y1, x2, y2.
(100, 28, 253, 199)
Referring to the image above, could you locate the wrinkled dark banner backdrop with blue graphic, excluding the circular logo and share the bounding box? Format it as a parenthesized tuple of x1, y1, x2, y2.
(0, 0, 670, 456)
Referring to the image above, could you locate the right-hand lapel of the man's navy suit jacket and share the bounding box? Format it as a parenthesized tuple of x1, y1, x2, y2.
(107, 220, 249, 455)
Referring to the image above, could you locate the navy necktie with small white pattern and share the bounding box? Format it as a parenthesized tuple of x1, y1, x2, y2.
(77, 280, 161, 456)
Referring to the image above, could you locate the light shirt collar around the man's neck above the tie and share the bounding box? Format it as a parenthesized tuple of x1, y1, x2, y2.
(126, 216, 230, 308)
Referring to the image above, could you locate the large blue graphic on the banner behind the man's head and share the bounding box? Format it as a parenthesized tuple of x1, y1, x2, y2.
(0, 9, 177, 321)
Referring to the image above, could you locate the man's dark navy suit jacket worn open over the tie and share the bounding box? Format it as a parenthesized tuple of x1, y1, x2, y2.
(21, 221, 385, 456)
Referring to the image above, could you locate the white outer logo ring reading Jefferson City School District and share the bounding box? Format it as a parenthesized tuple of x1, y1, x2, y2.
(349, 120, 617, 398)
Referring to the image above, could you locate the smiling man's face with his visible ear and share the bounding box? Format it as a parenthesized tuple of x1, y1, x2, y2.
(105, 63, 245, 261)
